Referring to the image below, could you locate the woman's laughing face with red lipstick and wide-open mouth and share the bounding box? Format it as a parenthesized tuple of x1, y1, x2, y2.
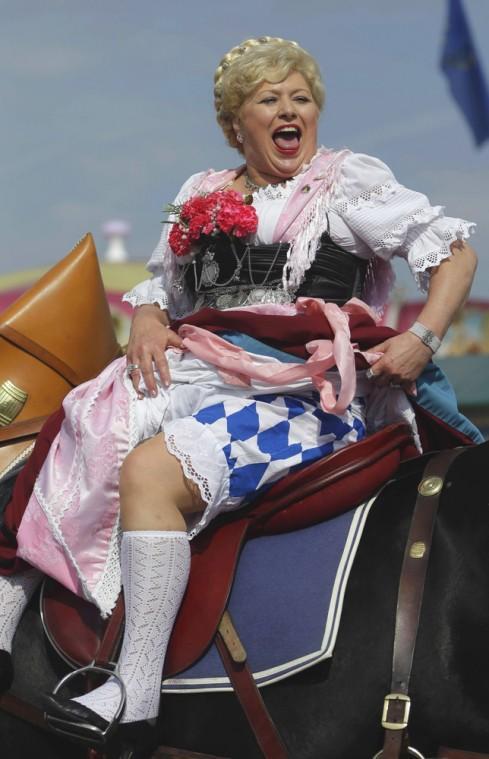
(233, 72, 319, 184)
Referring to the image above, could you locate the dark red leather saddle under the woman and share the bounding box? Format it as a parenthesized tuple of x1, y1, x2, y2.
(41, 424, 417, 678)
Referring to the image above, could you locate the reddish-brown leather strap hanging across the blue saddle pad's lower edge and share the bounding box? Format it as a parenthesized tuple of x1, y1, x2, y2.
(214, 612, 289, 759)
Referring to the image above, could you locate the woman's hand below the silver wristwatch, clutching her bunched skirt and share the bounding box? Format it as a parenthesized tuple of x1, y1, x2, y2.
(369, 332, 433, 392)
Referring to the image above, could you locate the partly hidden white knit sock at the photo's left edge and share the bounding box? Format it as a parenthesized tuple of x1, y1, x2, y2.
(0, 567, 42, 653)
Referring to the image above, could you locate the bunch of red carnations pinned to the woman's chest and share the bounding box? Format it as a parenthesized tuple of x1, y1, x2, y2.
(167, 190, 258, 257)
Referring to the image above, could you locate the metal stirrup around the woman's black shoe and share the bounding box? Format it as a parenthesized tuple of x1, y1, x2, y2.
(44, 664, 126, 746)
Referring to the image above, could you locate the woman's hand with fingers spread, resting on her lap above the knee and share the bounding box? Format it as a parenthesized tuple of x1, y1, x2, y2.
(127, 304, 182, 398)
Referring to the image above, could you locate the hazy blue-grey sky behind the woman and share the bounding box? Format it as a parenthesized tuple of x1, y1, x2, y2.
(0, 0, 489, 298)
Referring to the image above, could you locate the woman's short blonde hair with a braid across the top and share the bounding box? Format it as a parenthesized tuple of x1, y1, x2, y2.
(214, 37, 325, 152)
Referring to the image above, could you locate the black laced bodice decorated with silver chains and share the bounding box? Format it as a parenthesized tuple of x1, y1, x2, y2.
(182, 231, 368, 309)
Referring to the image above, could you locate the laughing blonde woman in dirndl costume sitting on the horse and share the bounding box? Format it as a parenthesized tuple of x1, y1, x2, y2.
(0, 37, 475, 748)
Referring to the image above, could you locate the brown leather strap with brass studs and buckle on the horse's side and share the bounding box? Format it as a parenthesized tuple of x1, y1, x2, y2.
(382, 448, 466, 759)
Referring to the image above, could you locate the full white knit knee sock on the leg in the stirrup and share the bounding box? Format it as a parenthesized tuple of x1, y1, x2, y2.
(74, 531, 190, 722)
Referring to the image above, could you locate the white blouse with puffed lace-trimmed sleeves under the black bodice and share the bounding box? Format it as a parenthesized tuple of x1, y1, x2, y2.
(123, 153, 476, 317)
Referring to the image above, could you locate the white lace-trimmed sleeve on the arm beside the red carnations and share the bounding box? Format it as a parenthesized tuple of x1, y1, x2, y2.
(122, 171, 207, 318)
